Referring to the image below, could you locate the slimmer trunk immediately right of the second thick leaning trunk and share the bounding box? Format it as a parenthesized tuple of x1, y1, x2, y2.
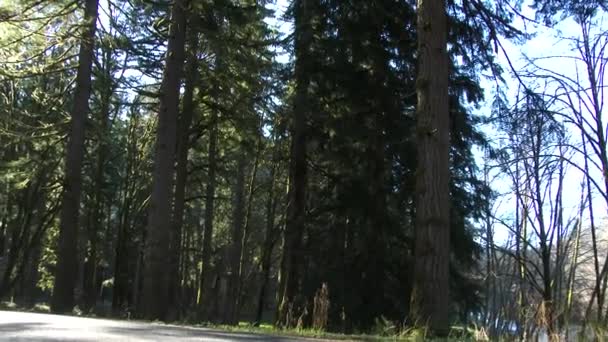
(169, 33, 198, 320)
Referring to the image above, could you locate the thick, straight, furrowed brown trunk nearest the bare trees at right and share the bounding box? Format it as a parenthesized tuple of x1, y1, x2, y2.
(411, 0, 450, 335)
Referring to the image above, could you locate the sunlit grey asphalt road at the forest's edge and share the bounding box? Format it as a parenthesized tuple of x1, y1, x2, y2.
(0, 311, 310, 342)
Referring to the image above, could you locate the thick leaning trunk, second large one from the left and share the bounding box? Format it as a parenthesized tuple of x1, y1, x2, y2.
(140, 0, 188, 319)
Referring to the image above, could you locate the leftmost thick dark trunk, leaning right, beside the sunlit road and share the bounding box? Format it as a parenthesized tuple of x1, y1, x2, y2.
(51, 0, 98, 312)
